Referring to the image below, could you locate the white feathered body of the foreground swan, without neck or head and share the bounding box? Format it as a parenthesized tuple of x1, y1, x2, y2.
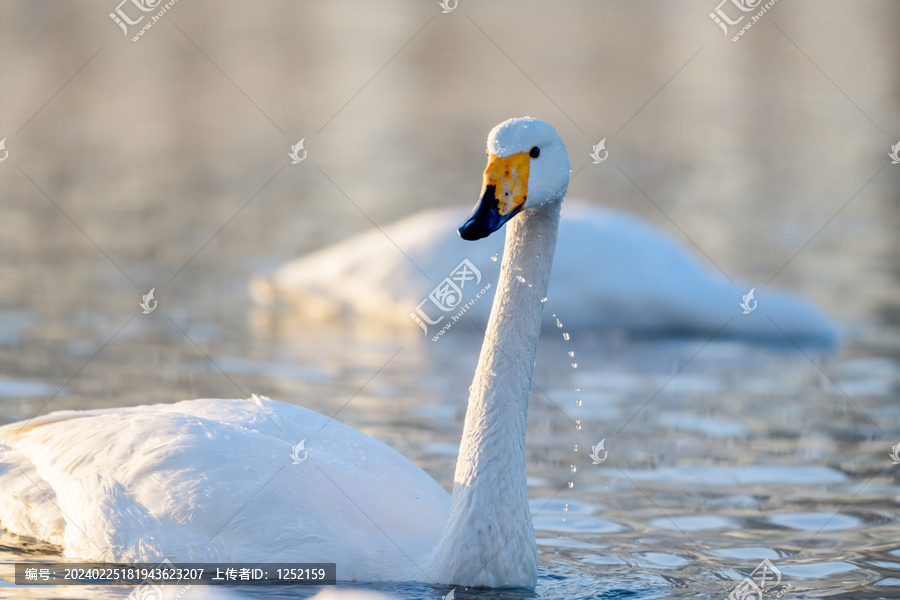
(0, 399, 449, 580)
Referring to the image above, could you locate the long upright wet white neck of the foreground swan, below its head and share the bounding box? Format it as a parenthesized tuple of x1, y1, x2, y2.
(426, 202, 560, 587)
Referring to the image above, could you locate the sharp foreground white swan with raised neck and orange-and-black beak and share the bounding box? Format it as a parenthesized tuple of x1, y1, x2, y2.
(0, 117, 570, 588)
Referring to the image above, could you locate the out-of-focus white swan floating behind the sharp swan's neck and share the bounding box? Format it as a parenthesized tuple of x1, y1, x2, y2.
(250, 200, 837, 347)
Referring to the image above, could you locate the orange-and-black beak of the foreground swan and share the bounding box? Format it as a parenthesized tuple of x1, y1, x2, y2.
(458, 152, 531, 240)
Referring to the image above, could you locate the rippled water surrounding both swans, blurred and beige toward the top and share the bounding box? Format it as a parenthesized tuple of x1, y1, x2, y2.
(0, 0, 900, 598)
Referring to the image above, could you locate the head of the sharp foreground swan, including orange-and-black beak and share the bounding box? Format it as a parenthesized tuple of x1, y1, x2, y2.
(458, 117, 570, 240)
